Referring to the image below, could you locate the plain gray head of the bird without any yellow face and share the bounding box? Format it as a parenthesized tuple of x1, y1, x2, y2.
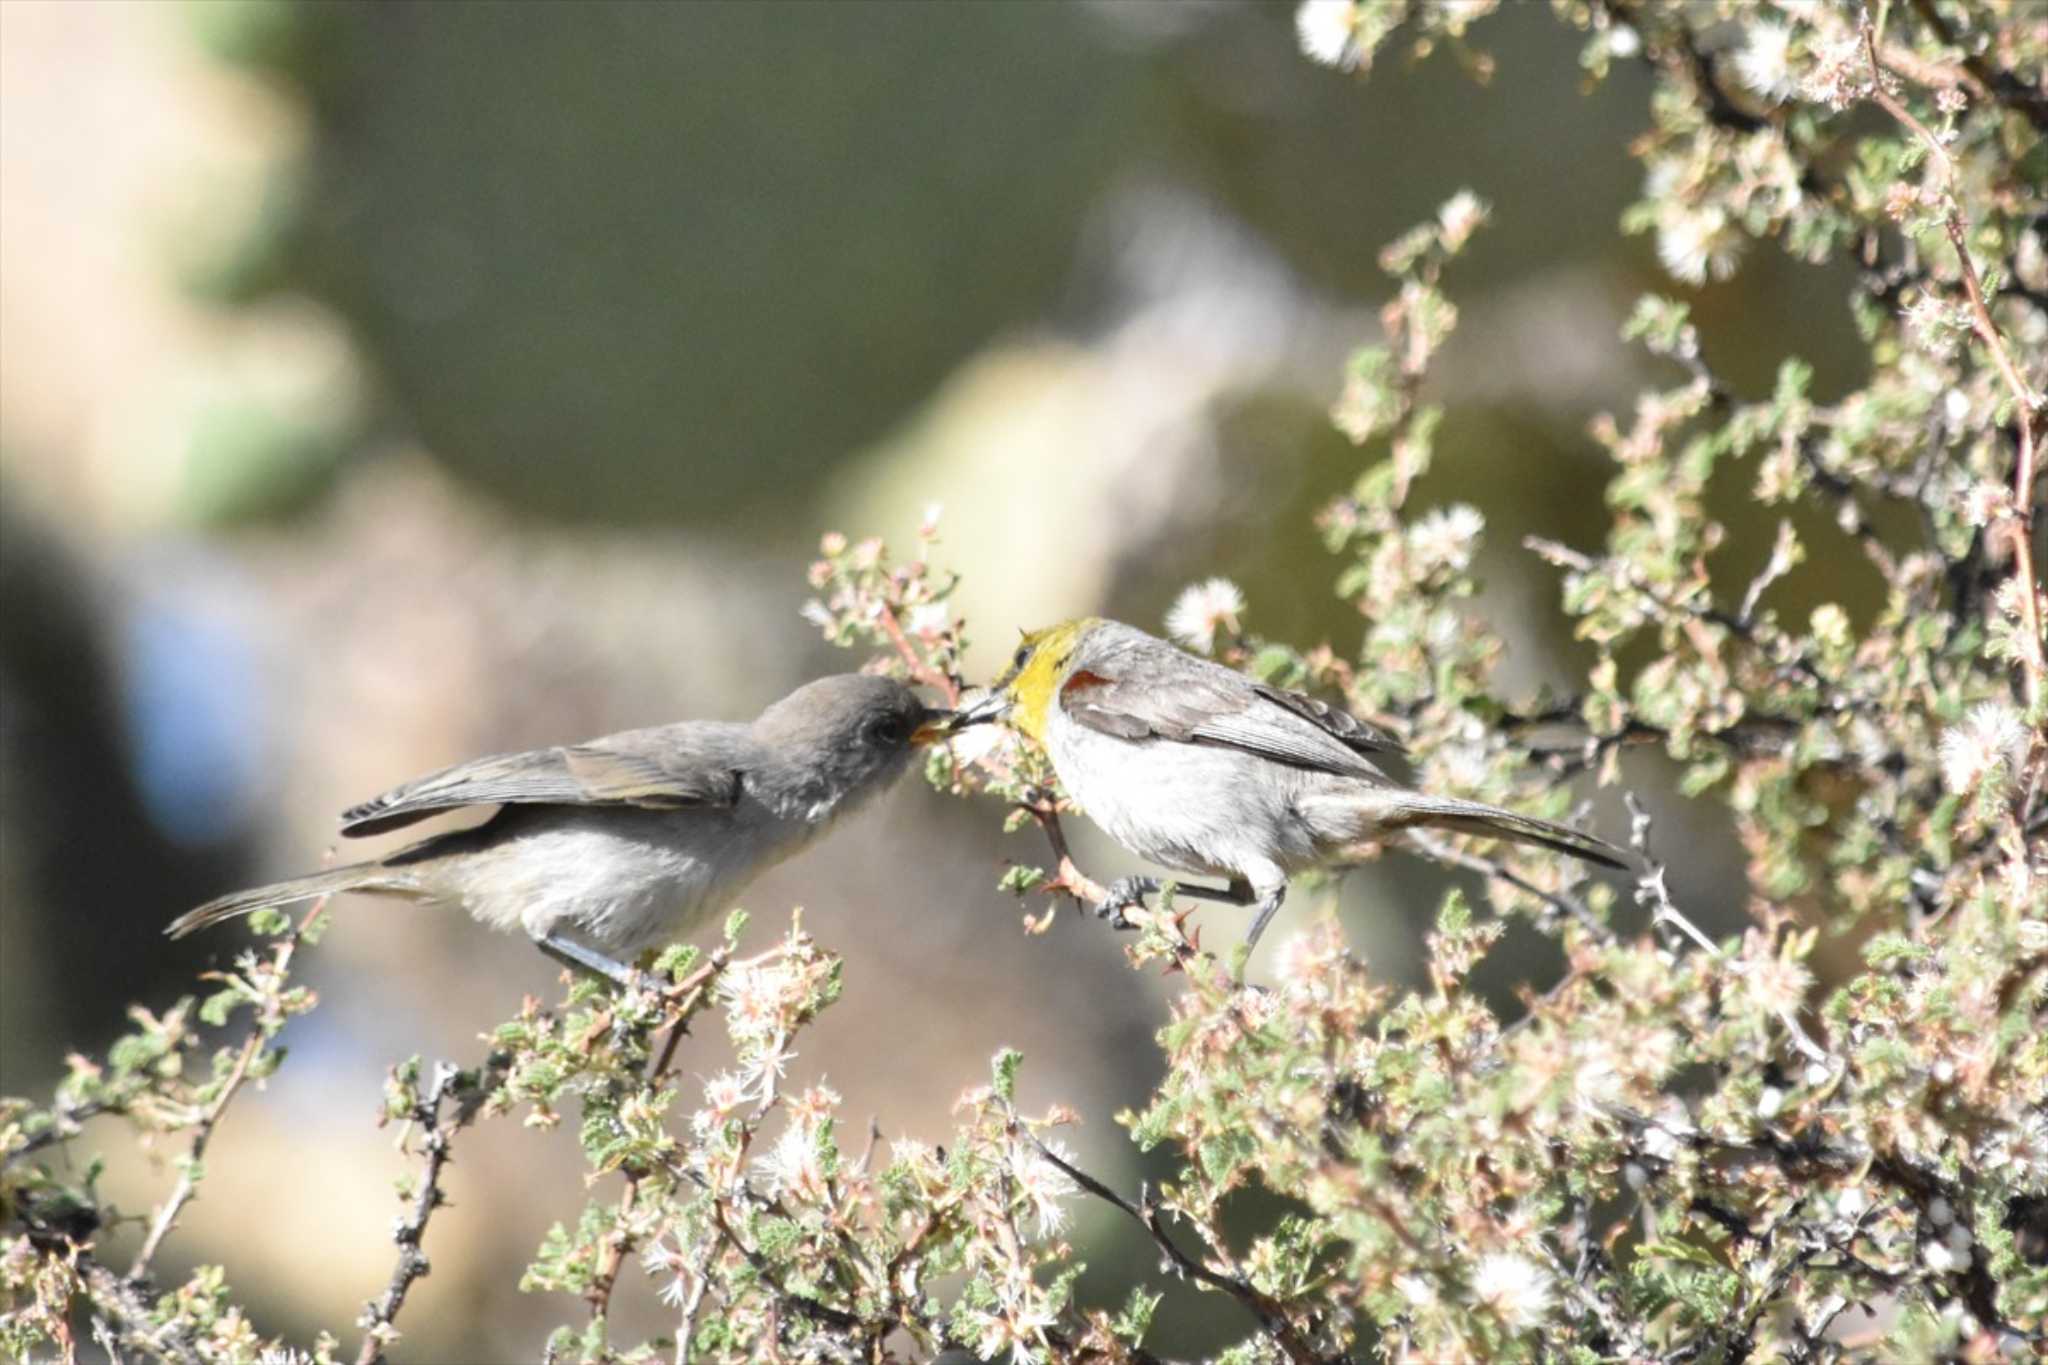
(750, 673, 952, 821)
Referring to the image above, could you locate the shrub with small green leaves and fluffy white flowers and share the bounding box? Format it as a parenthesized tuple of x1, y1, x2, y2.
(0, 0, 2048, 1363)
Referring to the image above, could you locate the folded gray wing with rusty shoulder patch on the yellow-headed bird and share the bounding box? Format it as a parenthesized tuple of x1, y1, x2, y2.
(1059, 645, 1397, 782)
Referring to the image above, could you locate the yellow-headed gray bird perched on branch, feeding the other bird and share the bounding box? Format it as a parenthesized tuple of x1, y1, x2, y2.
(952, 618, 1626, 948)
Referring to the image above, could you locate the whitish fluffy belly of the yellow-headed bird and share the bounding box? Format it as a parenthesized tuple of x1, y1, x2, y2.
(1047, 706, 1317, 890)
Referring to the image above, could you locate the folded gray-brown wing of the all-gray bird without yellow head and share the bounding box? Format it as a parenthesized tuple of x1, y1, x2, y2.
(342, 722, 745, 837)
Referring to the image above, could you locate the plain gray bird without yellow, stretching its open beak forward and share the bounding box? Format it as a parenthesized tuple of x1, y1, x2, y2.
(166, 673, 952, 982)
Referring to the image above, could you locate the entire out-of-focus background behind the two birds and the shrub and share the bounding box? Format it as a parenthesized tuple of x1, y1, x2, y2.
(0, 0, 1860, 1361)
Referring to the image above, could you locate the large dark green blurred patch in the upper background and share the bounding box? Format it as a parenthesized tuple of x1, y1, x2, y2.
(195, 0, 1143, 526)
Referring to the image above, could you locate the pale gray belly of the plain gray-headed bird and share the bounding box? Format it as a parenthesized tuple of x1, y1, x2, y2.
(420, 804, 813, 956)
